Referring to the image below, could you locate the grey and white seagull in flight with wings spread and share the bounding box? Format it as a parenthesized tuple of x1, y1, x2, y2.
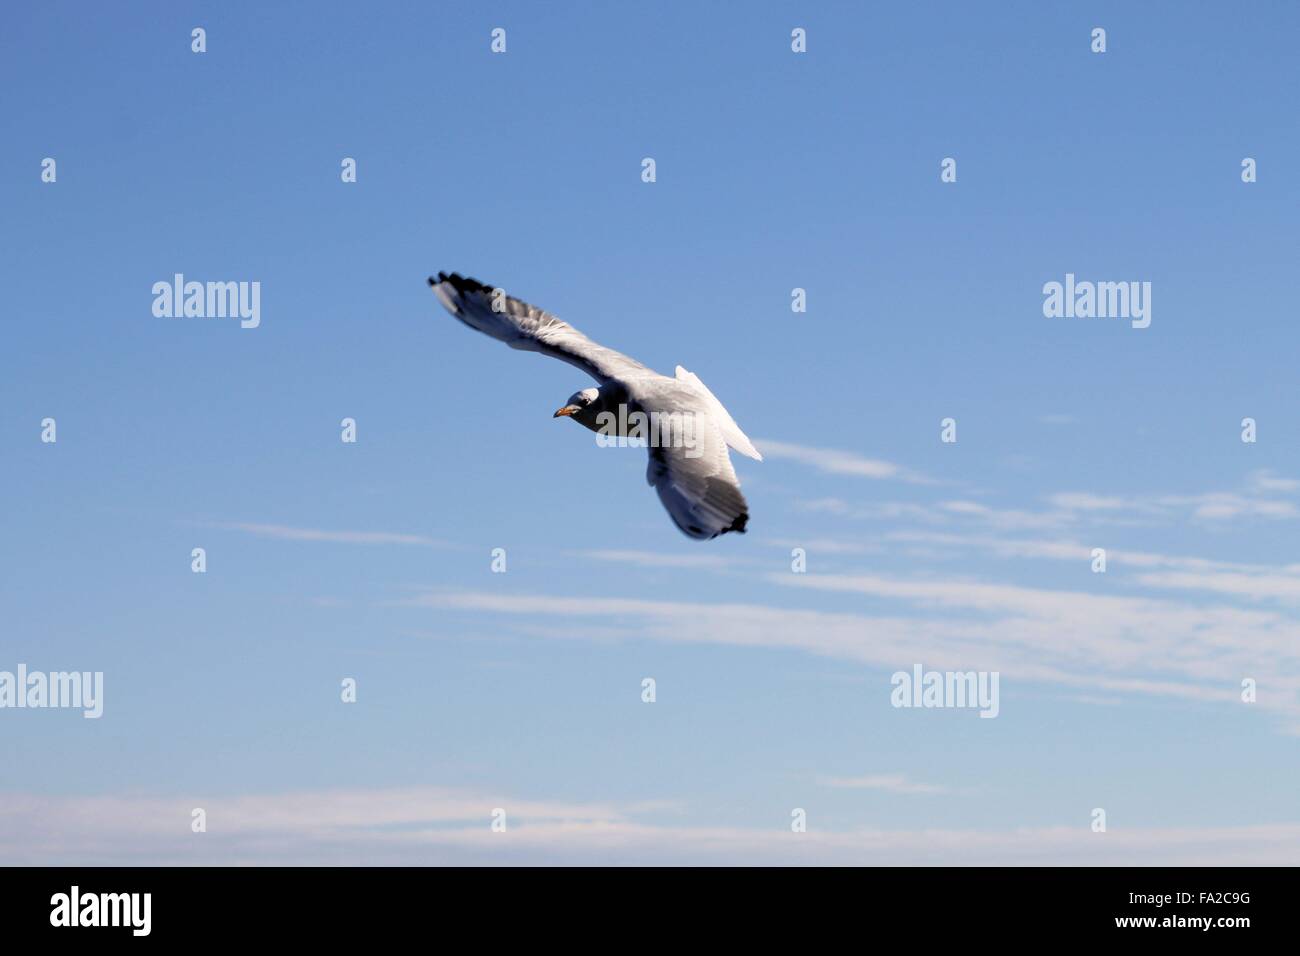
(429, 272, 763, 541)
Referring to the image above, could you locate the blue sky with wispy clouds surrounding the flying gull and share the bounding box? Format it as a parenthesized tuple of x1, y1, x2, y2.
(0, 3, 1300, 864)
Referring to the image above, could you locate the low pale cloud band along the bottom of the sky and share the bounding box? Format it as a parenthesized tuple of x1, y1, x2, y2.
(0, 787, 1300, 866)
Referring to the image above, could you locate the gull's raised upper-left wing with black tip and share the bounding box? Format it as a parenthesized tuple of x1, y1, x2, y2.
(429, 272, 653, 385)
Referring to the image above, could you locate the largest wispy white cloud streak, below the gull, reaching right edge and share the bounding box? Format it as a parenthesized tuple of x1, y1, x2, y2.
(404, 572, 1300, 730)
